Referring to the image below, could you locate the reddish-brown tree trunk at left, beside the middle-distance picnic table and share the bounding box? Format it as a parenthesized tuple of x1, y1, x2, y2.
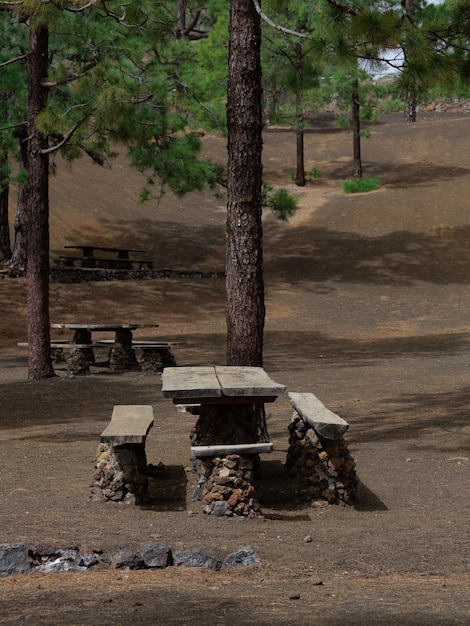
(26, 24, 54, 380)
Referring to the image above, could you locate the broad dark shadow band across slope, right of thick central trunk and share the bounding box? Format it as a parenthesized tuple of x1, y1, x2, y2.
(265, 225, 470, 286)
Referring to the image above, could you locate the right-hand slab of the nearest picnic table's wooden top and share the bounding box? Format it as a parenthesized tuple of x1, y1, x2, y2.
(215, 365, 286, 397)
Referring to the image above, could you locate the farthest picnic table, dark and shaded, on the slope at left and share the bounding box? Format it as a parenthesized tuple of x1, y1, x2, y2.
(58, 244, 152, 269)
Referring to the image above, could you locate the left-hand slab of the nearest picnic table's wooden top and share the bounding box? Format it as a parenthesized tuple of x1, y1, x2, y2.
(162, 367, 222, 404)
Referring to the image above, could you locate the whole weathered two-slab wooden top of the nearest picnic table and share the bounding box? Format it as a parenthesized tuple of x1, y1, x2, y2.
(162, 365, 286, 404)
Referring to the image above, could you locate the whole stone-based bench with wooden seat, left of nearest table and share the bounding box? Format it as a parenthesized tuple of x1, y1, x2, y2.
(92, 404, 154, 504)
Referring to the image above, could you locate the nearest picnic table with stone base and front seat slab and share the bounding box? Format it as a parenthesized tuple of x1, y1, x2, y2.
(162, 366, 286, 516)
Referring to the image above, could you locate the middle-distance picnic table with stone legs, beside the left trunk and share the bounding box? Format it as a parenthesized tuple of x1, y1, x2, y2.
(51, 323, 158, 370)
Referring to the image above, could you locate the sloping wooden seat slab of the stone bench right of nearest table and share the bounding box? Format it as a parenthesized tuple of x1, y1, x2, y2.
(288, 392, 349, 439)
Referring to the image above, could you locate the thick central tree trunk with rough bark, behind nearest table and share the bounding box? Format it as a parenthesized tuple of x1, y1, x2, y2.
(226, 0, 265, 366)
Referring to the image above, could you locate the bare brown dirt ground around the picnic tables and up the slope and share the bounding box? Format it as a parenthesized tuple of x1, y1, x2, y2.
(0, 112, 470, 626)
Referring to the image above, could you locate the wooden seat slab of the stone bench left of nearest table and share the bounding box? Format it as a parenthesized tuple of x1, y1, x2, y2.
(100, 404, 153, 445)
